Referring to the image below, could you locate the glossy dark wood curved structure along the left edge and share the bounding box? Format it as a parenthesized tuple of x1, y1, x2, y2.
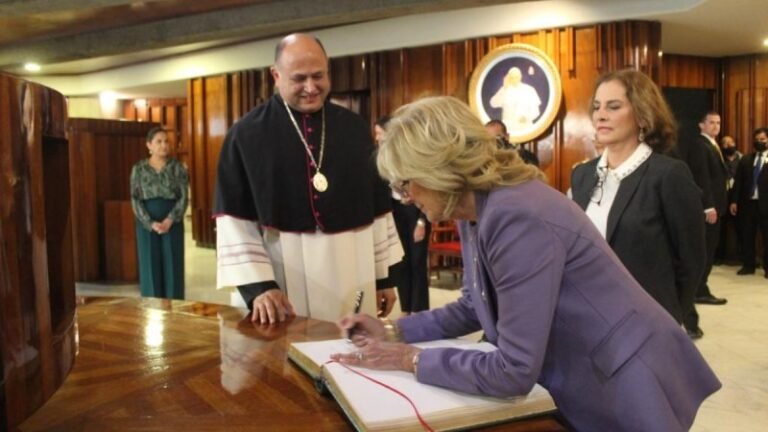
(0, 75, 75, 430)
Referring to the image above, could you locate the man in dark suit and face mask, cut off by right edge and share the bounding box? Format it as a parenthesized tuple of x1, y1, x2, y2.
(730, 128, 768, 278)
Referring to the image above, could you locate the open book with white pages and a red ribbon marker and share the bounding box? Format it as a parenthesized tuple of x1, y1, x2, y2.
(288, 339, 555, 431)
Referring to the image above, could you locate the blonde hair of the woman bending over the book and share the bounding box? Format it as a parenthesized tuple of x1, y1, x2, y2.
(376, 96, 545, 218)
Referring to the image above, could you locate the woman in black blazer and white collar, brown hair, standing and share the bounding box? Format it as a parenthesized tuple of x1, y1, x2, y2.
(571, 70, 705, 337)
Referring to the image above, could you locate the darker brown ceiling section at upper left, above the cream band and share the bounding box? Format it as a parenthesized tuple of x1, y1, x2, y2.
(0, 0, 523, 74)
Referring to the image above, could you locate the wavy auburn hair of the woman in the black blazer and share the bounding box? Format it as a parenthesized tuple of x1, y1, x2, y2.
(589, 69, 677, 153)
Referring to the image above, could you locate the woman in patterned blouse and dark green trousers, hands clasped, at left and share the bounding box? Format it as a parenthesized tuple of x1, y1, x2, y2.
(131, 127, 189, 299)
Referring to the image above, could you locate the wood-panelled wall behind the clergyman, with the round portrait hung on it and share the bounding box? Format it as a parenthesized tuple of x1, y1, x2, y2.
(188, 21, 661, 245)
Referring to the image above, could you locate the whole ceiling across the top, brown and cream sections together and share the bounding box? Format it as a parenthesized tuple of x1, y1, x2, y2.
(0, 0, 768, 97)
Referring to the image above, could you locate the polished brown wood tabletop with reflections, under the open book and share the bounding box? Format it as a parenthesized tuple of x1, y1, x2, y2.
(19, 297, 566, 432)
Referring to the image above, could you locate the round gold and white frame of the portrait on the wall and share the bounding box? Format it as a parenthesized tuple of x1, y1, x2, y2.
(467, 43, 563, 144)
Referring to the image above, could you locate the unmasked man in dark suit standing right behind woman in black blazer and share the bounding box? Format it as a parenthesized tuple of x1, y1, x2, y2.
(678, 111, 728, 337)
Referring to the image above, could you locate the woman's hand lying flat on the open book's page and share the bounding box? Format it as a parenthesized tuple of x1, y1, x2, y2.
(331, 338, 421, 372)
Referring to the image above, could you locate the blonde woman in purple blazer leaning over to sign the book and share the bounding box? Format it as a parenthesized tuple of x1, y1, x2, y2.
(334, 97, 720, 431)
